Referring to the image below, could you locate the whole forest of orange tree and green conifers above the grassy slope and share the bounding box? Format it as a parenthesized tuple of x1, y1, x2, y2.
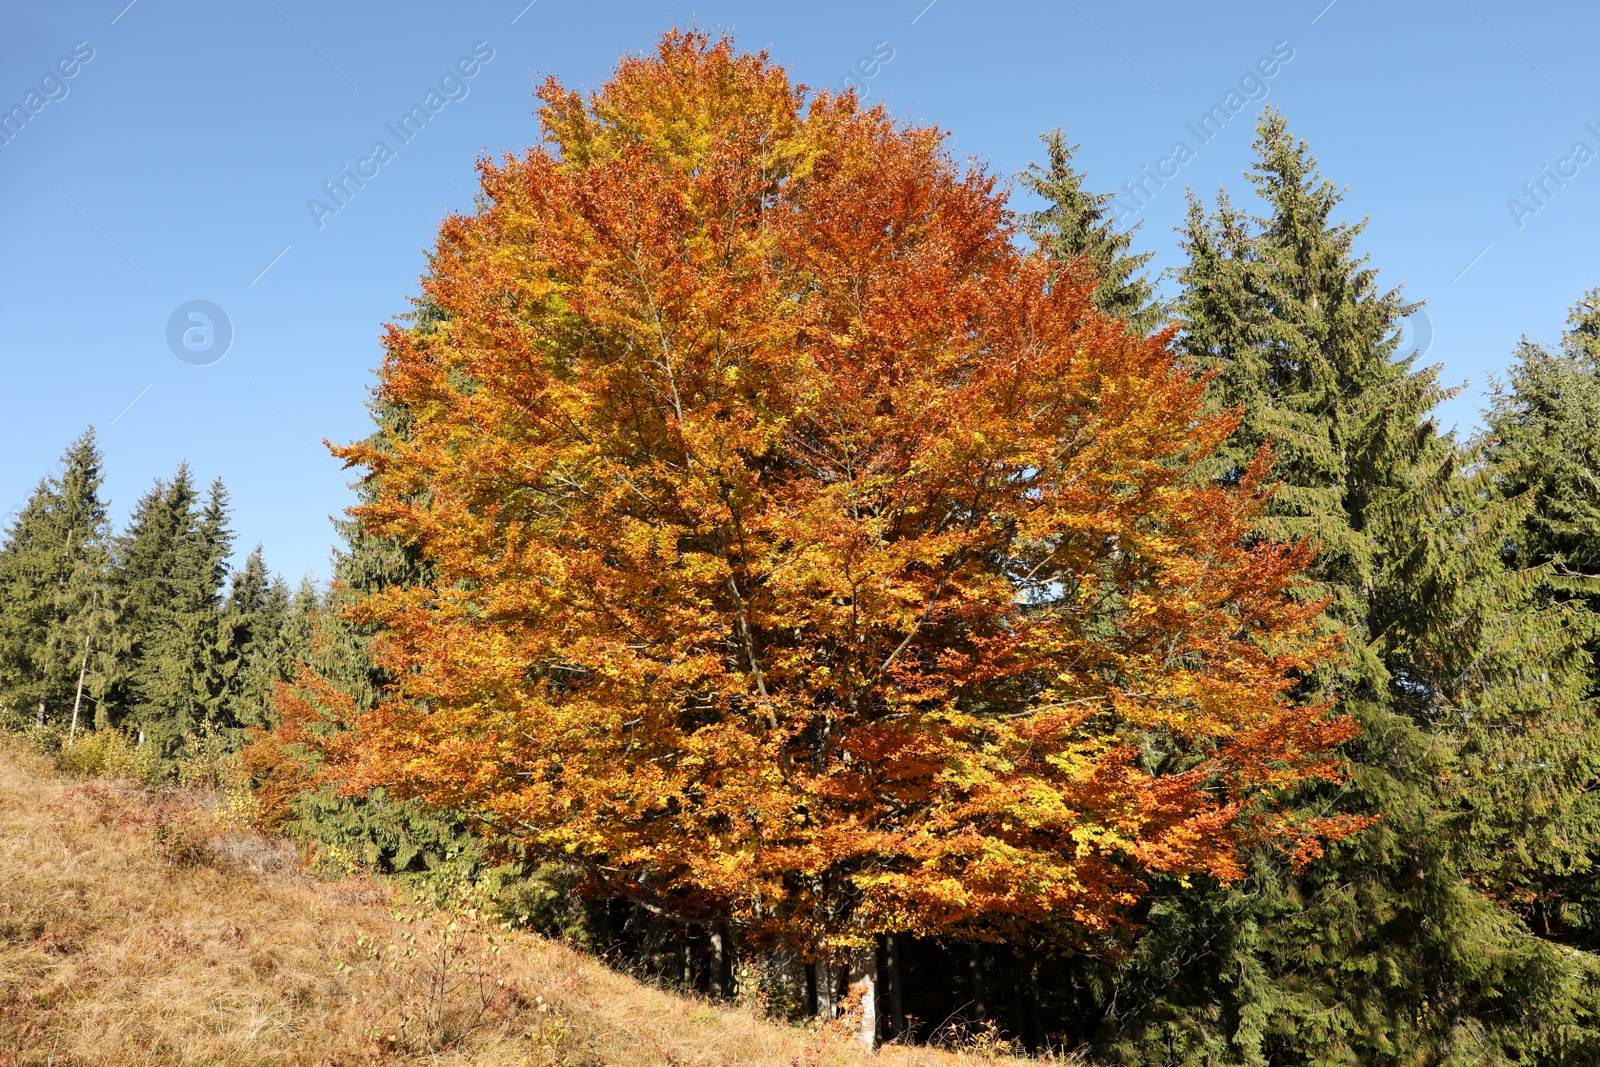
(0, 32, 1600, 1067)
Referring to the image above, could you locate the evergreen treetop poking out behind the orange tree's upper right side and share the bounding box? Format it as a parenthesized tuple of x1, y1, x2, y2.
(1019, 130, 1166, 333)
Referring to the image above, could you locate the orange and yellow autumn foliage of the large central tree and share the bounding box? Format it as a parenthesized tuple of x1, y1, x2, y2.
(315, 32, 1355, 949)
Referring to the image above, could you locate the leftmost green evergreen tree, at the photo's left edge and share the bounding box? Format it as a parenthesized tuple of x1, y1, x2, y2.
(0, 427, 107, 726)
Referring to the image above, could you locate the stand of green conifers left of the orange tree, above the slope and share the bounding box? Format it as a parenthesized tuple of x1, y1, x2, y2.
(0, 441, 300, 753)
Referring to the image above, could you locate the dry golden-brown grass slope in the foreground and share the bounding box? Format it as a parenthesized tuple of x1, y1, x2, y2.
(0, 744, 1049, 1067)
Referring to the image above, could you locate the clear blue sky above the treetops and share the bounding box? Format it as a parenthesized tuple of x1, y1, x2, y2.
(0, 0, 1600, 579)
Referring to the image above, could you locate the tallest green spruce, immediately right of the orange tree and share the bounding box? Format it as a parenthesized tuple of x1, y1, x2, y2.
(1062, 110, 1597, 1064)
